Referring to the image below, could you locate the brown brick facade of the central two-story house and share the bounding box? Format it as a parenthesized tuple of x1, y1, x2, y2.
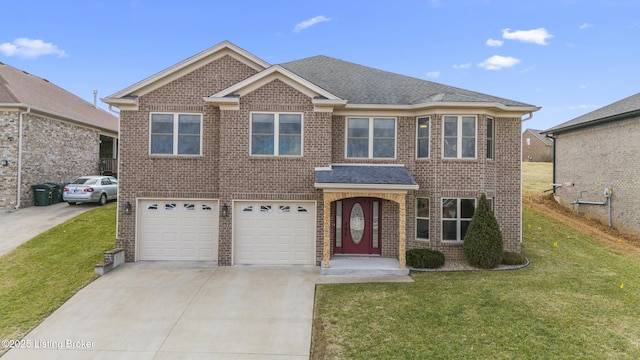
(112, 44, 521, 265)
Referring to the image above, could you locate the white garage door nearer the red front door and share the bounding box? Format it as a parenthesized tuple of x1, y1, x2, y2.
(233, 202, 316, 265)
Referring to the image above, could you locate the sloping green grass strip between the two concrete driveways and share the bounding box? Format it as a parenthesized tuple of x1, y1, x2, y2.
(0, 203, 116, 346)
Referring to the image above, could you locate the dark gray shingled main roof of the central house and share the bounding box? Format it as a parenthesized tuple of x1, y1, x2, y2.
(280, 56, 533, 107)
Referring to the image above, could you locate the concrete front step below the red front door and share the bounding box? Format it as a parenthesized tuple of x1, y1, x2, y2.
(320, 256, 409, 276)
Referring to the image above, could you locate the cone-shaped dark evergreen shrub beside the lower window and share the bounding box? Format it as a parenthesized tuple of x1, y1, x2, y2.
(462, 194, 503, 269)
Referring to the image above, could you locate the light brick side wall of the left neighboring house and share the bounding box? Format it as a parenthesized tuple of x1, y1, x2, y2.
(0, 111, 100, 209)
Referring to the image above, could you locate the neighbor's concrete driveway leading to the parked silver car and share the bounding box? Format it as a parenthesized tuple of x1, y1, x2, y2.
(0, 202, 96, 256)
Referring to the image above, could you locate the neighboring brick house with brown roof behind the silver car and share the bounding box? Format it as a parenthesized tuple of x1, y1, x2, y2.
(0, 63, 118, 210)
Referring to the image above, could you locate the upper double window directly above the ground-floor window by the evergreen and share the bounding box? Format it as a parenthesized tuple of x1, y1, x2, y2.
(442, 115, 477, 159)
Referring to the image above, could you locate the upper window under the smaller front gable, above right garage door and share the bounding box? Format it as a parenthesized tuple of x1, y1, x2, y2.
(251, 113, 302, 156)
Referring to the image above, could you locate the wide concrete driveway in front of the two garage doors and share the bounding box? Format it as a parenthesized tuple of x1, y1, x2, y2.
(2, 262, 320, 360)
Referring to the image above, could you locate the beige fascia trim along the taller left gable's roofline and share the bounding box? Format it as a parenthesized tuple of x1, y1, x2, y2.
(103, 41, 270, 105)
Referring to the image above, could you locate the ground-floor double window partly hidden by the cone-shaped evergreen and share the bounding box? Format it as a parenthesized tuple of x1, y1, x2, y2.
(442, 198, 476, 241)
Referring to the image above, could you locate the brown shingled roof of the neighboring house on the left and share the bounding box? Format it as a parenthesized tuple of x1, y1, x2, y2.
(0, 62, 118, 132)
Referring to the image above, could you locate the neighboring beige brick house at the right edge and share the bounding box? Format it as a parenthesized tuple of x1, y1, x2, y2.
(545, 93, 640, 233)
